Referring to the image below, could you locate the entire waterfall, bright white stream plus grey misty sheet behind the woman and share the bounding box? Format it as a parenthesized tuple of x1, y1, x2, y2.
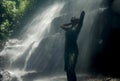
(0, 0, 105, 81)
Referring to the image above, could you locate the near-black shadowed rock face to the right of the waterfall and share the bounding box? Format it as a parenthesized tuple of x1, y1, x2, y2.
(92, 0, 120, 77)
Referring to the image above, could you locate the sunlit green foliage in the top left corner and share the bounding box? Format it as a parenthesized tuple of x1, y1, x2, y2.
(0, 0, 33, 39)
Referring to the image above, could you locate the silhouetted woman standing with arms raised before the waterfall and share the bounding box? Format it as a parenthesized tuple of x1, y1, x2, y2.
(61, 11, 85, 81)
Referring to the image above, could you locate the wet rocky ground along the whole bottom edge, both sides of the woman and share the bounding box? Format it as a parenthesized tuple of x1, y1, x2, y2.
(0, 71, 120, 81)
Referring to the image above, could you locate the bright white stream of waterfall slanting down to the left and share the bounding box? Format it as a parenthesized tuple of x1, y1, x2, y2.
(0, 2, 64, 81)
